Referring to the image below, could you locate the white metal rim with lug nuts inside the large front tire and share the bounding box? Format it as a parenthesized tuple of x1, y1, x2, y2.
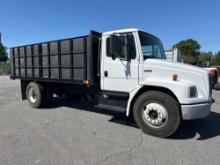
(142, 102, 168, 128)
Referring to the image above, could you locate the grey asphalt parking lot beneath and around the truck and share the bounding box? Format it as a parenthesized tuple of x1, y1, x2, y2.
(0, 77, 220, 165)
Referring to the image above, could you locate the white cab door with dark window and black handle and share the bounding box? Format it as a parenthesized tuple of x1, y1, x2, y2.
(101, 33, 139, 93)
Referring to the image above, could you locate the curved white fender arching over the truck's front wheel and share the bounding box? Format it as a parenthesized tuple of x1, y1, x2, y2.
(126, 78, 205, 116)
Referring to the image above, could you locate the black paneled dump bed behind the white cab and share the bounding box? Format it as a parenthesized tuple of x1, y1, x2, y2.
(10, 31, 101, 83)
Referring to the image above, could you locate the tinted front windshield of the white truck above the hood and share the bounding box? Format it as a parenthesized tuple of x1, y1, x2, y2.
(139, 31, 165, 60)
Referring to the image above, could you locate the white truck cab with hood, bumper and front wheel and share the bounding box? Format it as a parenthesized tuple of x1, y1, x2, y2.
(101, 29, 212, 136)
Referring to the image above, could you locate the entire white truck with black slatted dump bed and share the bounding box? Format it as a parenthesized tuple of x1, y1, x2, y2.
(10, 28, 212, 137)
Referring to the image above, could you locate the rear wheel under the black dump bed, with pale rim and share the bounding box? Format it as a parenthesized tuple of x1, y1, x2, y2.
(26, 82, 48, 108)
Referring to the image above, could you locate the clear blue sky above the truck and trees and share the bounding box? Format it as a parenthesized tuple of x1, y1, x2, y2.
(0, 0, 220, 52)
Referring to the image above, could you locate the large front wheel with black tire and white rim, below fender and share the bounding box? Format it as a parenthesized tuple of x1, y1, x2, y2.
(133, 91, 181, 137)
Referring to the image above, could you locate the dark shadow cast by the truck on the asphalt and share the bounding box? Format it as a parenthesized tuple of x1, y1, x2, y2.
(42, 97, 220, 140)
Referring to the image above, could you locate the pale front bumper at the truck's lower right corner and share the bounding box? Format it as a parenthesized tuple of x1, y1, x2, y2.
(181, 102, 212, 120)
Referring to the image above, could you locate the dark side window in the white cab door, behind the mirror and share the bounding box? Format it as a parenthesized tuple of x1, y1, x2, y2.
(106, 33, 136, 59)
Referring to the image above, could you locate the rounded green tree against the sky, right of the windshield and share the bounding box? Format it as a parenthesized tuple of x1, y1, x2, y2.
(173, 39, 201, 57)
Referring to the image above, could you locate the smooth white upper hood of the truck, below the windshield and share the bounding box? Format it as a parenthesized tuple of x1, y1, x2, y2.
(143, 59, 211, 100)
